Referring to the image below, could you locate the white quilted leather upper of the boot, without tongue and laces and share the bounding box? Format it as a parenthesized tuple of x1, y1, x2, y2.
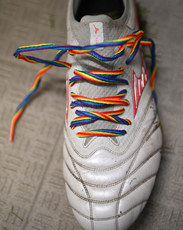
(63, 0, 162, 230)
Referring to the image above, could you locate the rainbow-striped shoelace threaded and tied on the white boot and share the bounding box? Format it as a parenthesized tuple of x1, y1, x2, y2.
(10, 30, 156, 141)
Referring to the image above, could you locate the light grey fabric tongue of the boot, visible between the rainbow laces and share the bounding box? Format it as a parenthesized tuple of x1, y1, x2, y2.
(73, 15, 125, 144)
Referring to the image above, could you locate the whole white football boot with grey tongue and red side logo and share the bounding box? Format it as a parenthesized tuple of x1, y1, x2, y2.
(64, 0, 162, 230)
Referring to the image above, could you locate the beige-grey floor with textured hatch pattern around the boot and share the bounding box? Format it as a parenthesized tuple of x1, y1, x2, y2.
(0, 0, 183, 230)
